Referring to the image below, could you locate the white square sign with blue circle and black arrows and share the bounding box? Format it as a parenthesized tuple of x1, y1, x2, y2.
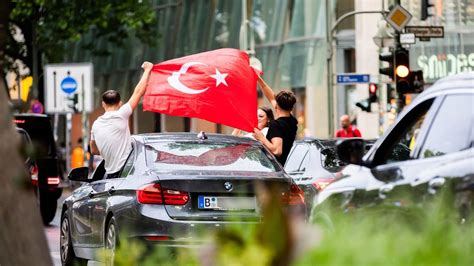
(44, 63, 94, 113)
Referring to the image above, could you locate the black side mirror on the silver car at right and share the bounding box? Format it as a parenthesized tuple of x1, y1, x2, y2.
(336, 139, 365, 165)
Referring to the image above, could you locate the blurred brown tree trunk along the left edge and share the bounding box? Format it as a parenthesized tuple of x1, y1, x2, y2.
(0, 1, 52, 265)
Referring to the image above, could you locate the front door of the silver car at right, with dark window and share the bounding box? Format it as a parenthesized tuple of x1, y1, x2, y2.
(362, 97, 442, 205)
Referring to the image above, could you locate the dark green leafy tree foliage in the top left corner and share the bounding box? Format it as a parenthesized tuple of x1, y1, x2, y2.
(0, 0, 157, 105)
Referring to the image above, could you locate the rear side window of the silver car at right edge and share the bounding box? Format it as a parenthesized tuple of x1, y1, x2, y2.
(420, 94, 474, 158)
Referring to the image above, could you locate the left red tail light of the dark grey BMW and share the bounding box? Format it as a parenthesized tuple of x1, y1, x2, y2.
(137, 183, 189, 205)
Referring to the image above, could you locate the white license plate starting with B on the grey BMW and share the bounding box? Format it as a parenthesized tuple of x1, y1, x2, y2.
(198, 196, 257, 210)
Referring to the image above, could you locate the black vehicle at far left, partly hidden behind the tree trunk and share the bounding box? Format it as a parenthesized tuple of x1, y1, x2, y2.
(13, 114, 62, 224)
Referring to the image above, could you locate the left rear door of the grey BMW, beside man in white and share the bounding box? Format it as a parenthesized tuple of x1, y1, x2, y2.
(88, 145, 136, 247)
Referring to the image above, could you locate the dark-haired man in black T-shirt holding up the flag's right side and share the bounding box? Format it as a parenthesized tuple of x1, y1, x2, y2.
(254, 76, 298, 166)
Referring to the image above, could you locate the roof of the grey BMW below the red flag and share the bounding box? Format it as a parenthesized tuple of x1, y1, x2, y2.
(133, 132, 261, 145)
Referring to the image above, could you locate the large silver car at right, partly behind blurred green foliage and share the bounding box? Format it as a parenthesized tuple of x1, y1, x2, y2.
(317, 72, 474, 218)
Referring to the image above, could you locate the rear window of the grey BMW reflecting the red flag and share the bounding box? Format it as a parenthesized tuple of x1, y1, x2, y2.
(146, 142, 279, 172)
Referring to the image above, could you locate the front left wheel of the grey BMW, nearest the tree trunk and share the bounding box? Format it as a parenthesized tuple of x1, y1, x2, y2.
(59, 212, 87, 266)
